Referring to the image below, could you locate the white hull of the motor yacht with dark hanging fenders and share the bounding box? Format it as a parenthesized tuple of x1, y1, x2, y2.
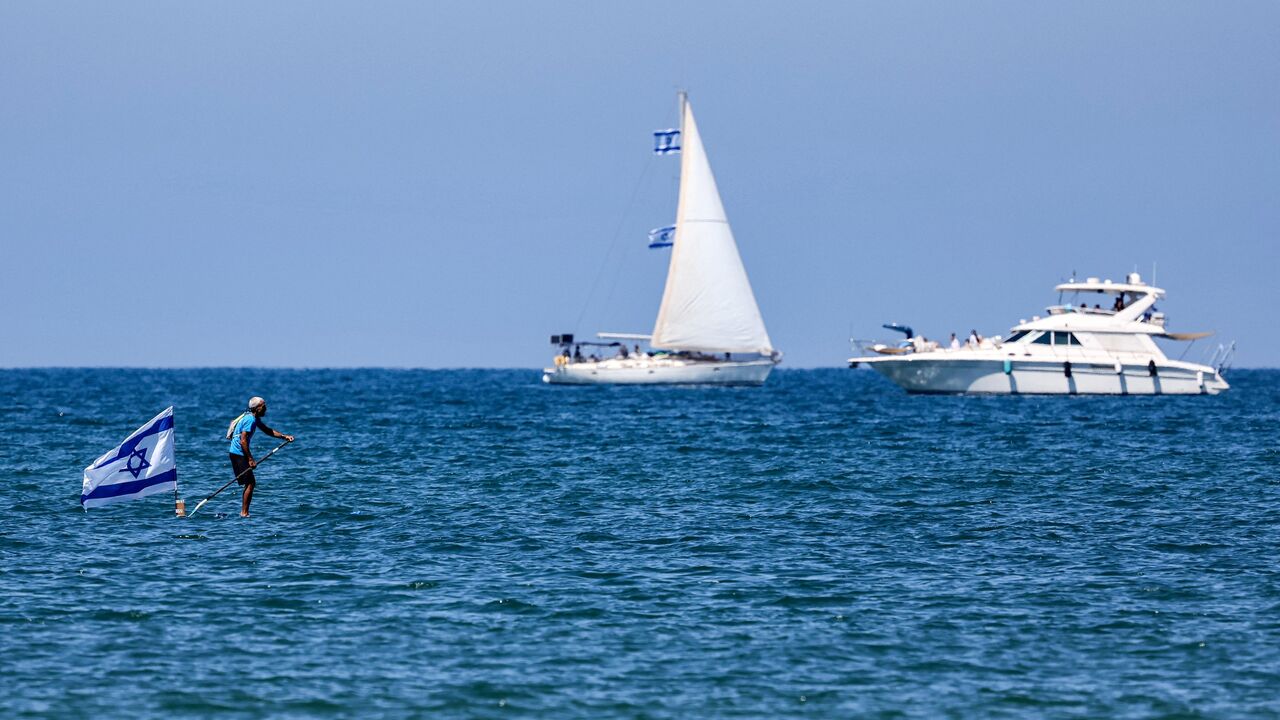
(864, 356, 1229, 395)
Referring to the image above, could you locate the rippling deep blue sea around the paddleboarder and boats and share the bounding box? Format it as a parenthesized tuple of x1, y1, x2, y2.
(0, 369, 1280, 719)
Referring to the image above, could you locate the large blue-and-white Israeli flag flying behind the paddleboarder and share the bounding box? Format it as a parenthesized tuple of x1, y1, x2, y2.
(81, 407, 178, 510)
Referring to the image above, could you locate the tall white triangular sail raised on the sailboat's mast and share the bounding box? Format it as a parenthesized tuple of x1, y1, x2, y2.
(650, 100, 773, 355)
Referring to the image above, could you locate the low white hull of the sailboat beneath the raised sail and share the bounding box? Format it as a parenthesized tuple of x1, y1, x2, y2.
(543, 357, 774, 386)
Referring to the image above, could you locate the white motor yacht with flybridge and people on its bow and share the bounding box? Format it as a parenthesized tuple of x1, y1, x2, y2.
(849, 273, 1235, 395)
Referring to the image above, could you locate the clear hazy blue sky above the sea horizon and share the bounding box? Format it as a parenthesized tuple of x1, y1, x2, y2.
(0, 0, 1280, 368)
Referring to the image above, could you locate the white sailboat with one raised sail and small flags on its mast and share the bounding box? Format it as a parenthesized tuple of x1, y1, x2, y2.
(543, 92, 782, 386)
